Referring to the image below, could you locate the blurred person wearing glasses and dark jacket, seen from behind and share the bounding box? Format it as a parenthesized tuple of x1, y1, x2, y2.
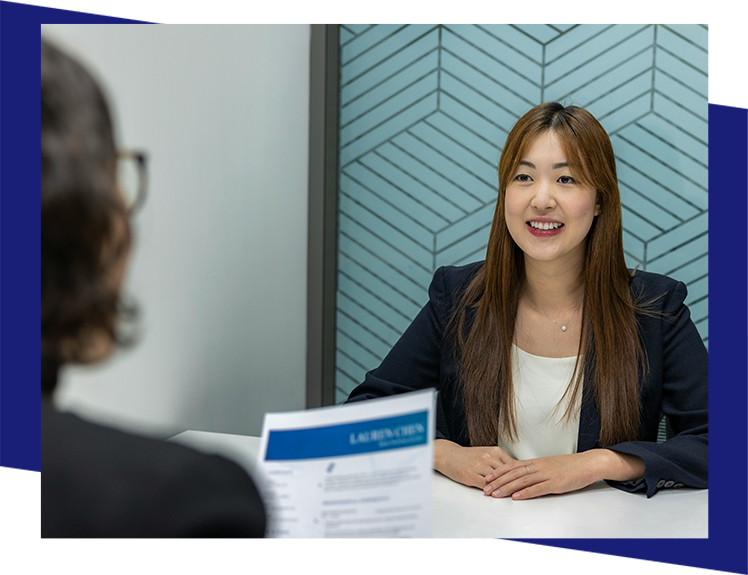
(39, 39, 265, 543)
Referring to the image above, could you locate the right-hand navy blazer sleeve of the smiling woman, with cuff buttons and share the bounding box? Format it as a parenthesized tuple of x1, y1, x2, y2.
(608, 282, 709, 497)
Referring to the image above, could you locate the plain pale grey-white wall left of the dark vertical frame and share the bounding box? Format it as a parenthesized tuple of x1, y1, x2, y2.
(41, 24, 310, 435)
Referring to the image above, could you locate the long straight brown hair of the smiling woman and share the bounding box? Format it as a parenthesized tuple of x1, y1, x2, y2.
(450, 102, 647, 446)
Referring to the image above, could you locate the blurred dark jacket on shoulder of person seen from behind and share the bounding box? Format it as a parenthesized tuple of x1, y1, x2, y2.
(40, 400, 265, 542)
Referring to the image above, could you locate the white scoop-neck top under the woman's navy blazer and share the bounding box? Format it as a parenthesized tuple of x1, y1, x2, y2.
(498, 344, 582, 459)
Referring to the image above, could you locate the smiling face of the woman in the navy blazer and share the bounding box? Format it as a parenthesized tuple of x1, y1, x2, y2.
(505, 130, 600, 272)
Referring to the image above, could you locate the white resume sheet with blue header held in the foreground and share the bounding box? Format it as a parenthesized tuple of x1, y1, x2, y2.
(256, 389, 436, 543)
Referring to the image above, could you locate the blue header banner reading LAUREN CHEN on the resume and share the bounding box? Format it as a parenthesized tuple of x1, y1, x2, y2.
(265, 411, 428, 461)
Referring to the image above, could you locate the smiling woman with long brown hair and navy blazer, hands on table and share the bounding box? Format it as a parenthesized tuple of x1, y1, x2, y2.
(348, 103, 709, 500)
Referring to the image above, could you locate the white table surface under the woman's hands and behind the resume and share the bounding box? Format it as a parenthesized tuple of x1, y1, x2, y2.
(171, 431, 709, 543)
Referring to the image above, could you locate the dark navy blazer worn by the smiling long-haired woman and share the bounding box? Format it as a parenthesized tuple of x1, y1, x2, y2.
(348, 262, 709, 497)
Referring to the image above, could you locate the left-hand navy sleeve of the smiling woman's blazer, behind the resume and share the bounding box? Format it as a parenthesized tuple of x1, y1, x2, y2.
(346, 267, 451, 439)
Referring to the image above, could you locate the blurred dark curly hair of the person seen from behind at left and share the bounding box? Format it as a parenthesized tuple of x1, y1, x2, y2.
(41, 39, 130, 392)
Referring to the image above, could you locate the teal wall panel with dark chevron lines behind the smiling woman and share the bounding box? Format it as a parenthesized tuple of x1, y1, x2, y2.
(336, 24, 709, 402)
